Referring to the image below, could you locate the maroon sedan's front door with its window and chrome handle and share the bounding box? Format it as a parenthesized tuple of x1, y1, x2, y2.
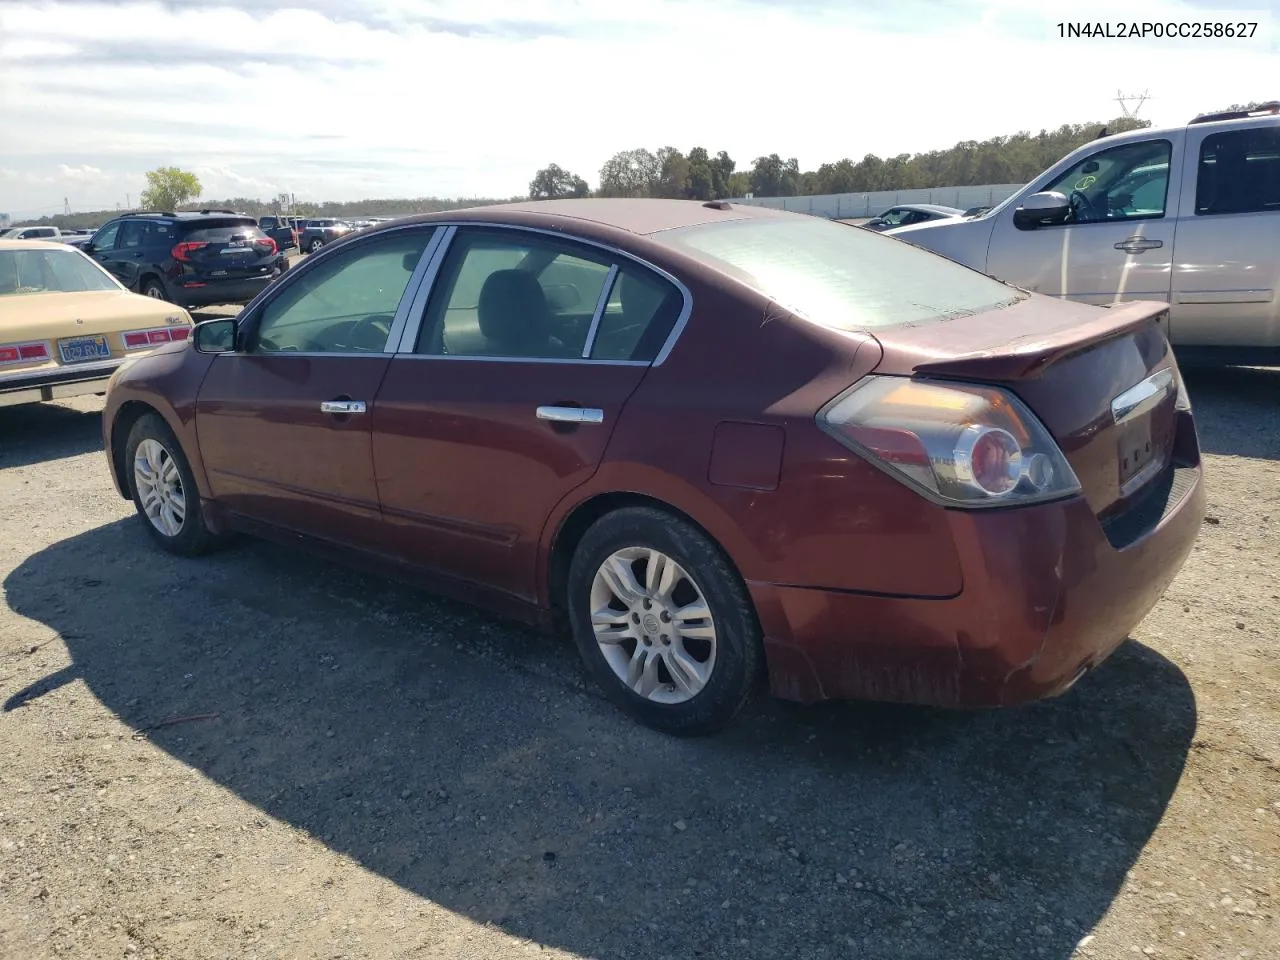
(196, 227, 434, 549)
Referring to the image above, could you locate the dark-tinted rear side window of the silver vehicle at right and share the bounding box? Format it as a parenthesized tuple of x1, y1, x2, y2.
(1196, 127, 1280, 215)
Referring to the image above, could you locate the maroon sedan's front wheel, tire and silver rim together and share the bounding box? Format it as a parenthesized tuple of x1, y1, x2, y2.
(124, 413, 218, 557)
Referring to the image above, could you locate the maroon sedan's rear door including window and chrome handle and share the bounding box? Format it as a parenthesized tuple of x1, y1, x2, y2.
(374, 227, 686, 600)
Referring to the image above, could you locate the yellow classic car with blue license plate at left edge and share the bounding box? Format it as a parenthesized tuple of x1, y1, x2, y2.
(0, 239, 192, 407)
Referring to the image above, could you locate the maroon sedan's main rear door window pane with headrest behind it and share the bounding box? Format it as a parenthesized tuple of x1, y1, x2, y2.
(416, 229, 612, 360)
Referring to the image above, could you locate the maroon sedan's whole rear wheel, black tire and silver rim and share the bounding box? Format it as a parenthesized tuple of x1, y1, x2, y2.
(567, 507, 764, 736)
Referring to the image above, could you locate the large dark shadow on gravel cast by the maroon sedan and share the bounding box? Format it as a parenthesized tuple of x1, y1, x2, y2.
(3, 518, 1197, 960)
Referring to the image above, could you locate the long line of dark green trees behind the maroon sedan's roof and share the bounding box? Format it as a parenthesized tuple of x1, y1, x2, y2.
(529, 118, 1151, 200)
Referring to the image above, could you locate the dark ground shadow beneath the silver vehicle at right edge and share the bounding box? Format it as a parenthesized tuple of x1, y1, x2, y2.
(1183, 366, 1280, 460)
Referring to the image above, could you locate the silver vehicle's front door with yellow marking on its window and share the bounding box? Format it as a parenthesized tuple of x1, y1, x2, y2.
(987, 138, 1181, 320)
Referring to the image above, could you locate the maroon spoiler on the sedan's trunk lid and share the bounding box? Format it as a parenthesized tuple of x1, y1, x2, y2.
(914, 300, 1169, 380)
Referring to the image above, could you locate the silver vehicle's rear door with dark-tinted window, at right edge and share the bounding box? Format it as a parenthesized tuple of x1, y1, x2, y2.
(1172, 124, 1280, 347)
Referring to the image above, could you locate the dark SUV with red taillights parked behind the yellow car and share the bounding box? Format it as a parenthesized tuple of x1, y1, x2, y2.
(81, 210, 289, 307)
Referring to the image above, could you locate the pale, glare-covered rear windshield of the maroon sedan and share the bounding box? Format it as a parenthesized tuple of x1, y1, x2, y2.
(653, 216, 1024, 332)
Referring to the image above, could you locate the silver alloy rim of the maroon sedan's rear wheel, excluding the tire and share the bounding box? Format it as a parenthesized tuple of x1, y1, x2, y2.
(590, 547, 716, 704)
